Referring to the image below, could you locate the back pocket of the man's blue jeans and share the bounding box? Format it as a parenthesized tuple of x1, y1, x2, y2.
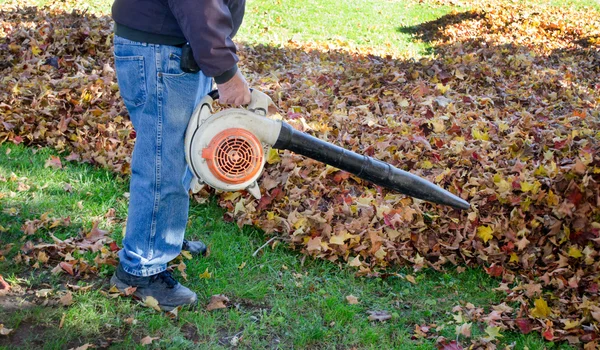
(115, 54, 146, 107)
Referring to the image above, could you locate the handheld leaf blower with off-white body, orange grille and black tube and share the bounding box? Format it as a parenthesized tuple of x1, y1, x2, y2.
(185, 90, 470, 210)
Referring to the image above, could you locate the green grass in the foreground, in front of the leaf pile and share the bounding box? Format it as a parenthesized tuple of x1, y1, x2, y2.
(0, 144, 567, 349)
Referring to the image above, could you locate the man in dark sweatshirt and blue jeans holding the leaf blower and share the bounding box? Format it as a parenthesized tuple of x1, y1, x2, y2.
(111, 0, 251, 310)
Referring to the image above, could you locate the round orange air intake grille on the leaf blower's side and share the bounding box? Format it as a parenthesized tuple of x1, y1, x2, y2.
(202, 128, 264, 184)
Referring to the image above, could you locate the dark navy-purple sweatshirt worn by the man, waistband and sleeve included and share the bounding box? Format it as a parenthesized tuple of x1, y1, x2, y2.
(112, 0, 246, 84)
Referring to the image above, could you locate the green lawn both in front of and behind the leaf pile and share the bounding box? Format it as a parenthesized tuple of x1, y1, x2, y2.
(0, 0, 600, 349)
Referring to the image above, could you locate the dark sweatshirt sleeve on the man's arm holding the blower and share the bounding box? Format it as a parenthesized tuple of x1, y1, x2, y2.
(168, 0, 244, 84)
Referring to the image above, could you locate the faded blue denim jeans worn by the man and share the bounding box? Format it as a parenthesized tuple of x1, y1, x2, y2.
(114, 35, 212, 276)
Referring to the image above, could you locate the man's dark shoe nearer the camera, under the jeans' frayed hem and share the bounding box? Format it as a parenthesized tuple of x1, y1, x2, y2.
(110, 264, 198, 311)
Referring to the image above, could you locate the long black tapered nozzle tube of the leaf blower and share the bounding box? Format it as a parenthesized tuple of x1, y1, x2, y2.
(273, 122, 471, 210)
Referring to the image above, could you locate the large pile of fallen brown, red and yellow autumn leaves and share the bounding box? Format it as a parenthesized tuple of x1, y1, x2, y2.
(0, 3, 600, 348)
